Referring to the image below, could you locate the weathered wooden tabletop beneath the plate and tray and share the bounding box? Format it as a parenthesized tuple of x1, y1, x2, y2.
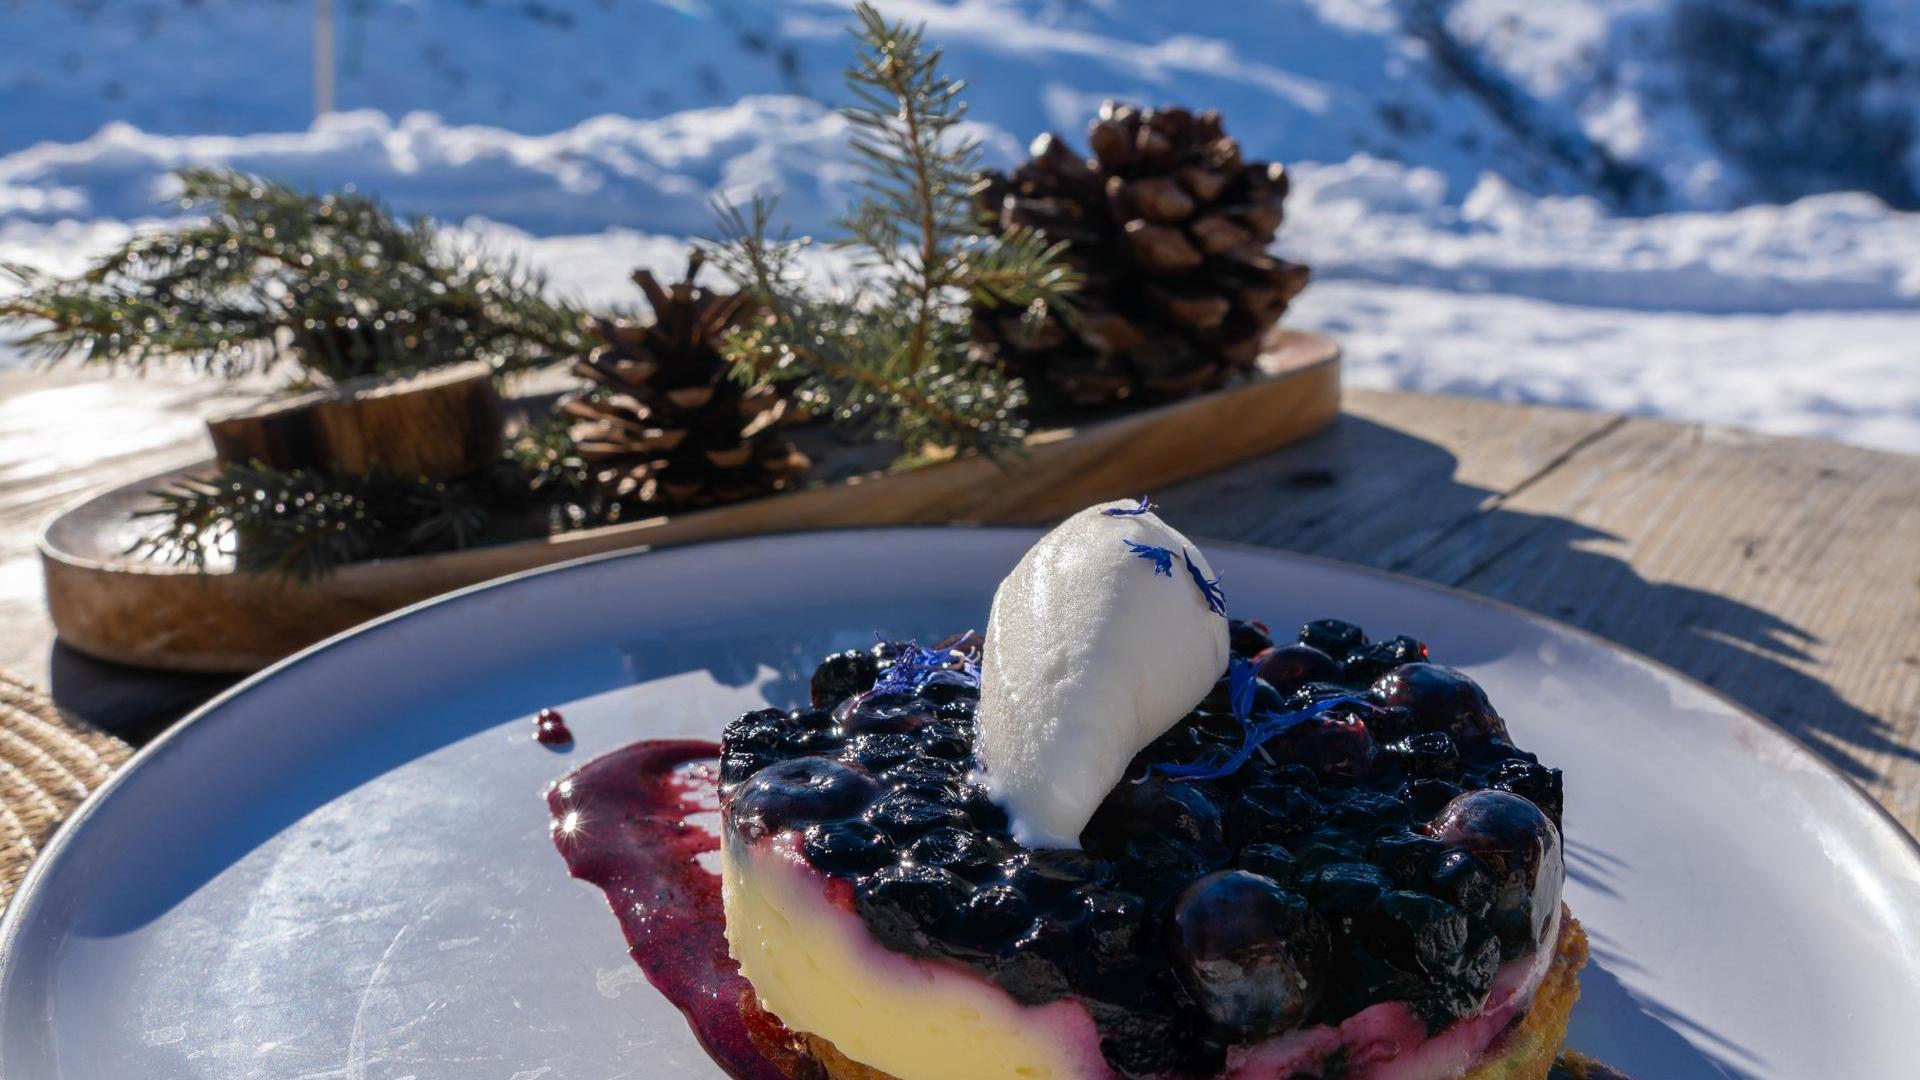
(0, 365, 1920, 830)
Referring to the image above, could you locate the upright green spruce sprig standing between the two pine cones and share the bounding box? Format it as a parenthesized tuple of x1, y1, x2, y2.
(703, 4, 1079, 457)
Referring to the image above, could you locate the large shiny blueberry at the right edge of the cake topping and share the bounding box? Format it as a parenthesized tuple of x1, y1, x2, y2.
(1427, 790, 1567, 959)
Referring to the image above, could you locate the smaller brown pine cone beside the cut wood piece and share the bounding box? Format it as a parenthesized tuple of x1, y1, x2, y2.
(561, 254, 810, 517)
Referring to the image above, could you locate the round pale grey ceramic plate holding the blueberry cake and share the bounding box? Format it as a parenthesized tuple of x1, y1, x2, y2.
(0, 530, 1920, 1080)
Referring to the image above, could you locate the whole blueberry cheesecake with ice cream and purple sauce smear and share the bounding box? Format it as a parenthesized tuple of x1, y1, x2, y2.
(549, 500, 1586, 1080)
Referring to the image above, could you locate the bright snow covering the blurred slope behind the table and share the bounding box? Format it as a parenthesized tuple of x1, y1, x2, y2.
(0, 0, 1920, 452)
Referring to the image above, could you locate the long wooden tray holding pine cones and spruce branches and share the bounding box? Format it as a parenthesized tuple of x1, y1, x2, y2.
(40, 331, 1340, 673)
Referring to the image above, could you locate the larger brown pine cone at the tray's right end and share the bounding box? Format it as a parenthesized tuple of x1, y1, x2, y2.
(973, 102, 1308, 411)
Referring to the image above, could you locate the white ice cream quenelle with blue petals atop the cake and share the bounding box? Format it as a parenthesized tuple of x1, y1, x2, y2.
(975, 500, 1227, 847)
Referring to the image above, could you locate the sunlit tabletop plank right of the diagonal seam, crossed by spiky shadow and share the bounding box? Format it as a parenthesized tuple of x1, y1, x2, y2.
(1404, 413, 1920, 828)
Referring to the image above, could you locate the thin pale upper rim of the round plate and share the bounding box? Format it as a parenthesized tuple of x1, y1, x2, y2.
(0, 523, 1920, 991)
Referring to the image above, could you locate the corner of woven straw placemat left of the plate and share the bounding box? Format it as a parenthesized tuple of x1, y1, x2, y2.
(0, 671, 132, 909)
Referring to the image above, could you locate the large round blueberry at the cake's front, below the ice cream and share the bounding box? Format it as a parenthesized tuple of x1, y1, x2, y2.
(1167, 871, 1329, 1040)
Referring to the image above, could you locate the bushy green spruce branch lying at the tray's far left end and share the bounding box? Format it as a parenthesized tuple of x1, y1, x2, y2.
(0, 169, 582, 380)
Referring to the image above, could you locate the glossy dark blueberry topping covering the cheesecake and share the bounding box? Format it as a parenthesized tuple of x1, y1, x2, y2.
(720, 619, 1565, 1076)
